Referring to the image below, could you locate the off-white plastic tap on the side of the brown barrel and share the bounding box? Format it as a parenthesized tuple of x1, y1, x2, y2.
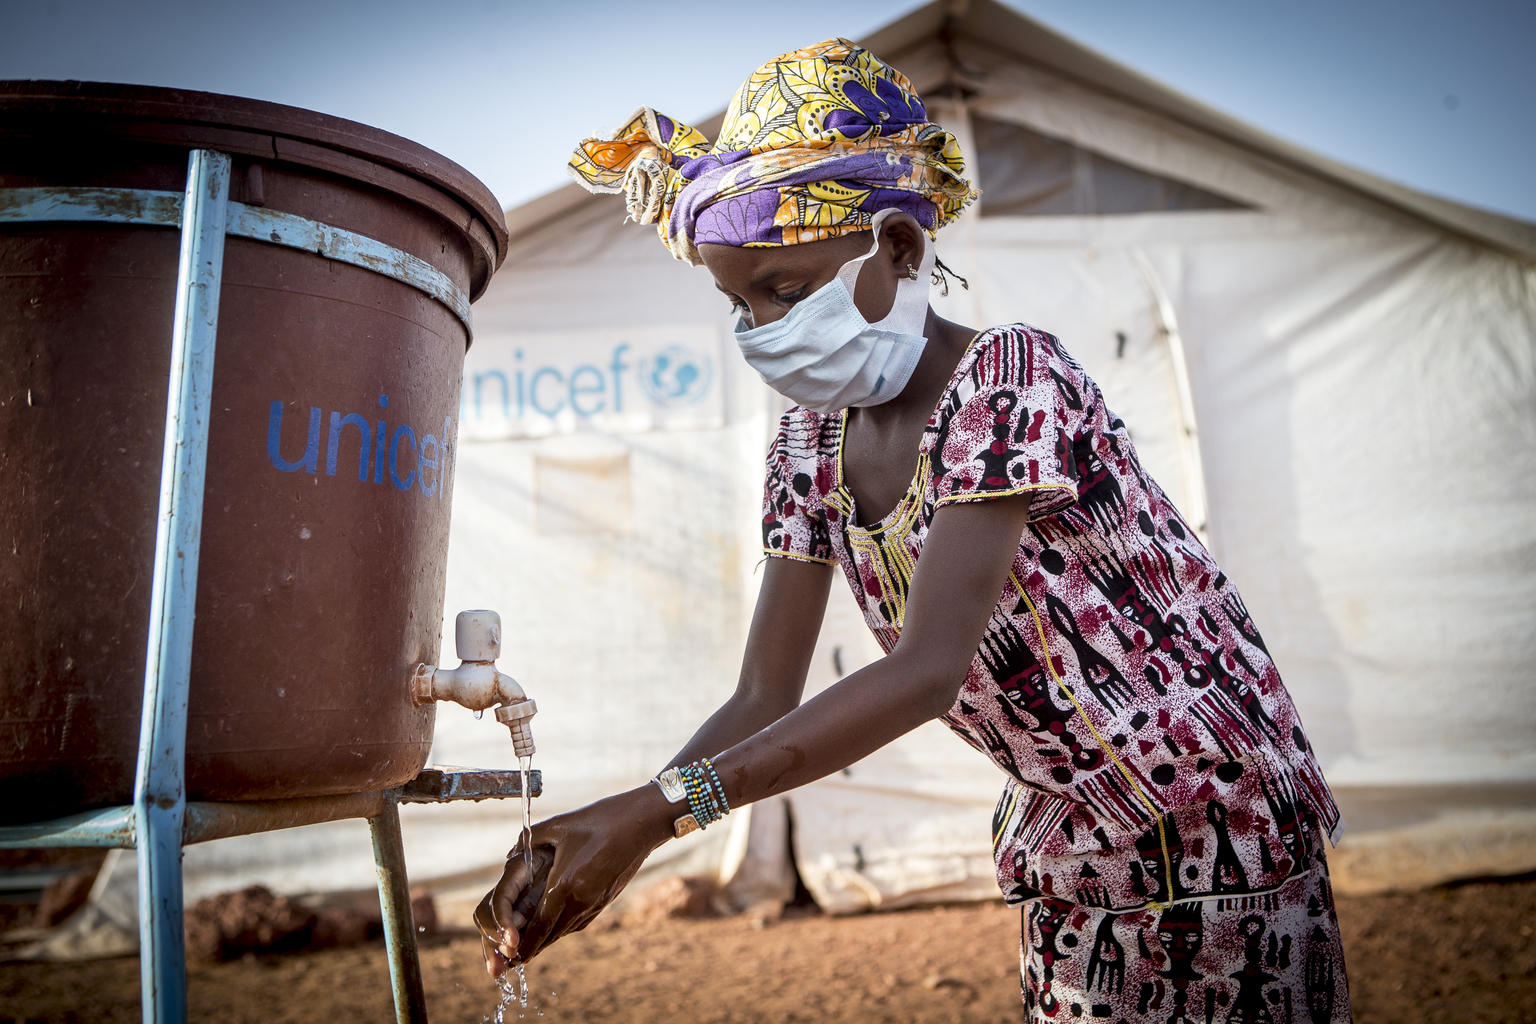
(410, 609, 538, 757)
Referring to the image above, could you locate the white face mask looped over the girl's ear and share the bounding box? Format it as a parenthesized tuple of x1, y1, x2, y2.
(736, 209, 934, 413)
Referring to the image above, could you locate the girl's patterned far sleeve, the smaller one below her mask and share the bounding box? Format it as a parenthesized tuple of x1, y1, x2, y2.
(763, 408, 837, 565)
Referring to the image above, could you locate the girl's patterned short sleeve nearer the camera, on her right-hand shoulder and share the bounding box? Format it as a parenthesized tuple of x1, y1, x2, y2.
(926, 327, 1078, 520)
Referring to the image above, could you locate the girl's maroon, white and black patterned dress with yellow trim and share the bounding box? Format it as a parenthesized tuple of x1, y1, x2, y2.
(763, 324, 1350, 1024)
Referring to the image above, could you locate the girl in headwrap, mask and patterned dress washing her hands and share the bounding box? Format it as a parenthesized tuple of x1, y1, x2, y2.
(476, 40, 1350, 1024)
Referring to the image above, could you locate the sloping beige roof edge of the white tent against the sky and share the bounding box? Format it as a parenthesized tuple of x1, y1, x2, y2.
(507, 0, 1536, 259)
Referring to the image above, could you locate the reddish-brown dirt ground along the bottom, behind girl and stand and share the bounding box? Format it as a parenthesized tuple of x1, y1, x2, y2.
(0, 878, 1536, 1024)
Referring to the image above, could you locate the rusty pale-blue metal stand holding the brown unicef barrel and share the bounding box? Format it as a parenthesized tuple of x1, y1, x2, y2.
(0, 149, 539, 1024)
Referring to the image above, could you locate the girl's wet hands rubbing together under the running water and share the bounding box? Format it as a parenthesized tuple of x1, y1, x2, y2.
(475, 786, 671, 978)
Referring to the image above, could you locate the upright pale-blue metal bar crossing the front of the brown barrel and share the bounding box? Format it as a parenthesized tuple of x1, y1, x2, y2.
(134, 149, 229, 1024)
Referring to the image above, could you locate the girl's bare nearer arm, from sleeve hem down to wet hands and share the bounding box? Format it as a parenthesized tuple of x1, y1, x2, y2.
(476, 496, 1029, 973)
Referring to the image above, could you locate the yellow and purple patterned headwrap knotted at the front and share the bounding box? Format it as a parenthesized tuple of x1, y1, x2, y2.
(570, 38, 977, 266)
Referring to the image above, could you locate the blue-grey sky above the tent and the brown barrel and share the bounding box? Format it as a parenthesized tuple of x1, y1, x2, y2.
(0, 0, 1536, 221)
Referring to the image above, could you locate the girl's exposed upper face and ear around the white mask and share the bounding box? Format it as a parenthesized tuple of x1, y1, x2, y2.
(699, 220, 922, 327)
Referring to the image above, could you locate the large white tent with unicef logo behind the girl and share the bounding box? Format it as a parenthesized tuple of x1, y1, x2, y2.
(144, 0, 1536, 910)
